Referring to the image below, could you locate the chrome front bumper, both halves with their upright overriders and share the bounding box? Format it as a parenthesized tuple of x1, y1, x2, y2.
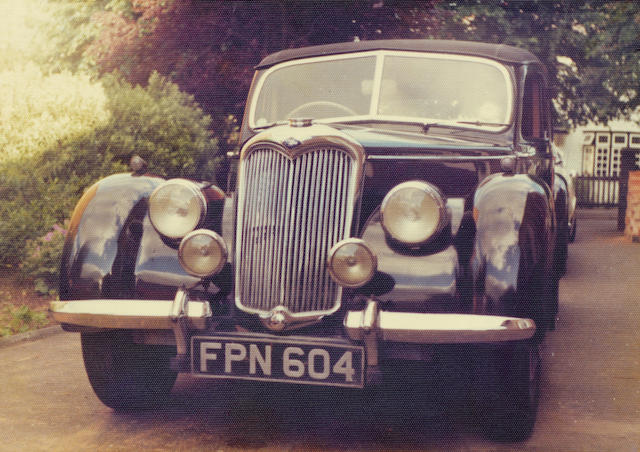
(50, 289, 536, 384)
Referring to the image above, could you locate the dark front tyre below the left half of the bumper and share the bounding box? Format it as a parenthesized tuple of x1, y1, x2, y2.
(81, 330, 177, 410)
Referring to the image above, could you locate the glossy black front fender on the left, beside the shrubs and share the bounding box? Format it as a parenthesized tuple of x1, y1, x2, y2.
(60, 174, 231, 300)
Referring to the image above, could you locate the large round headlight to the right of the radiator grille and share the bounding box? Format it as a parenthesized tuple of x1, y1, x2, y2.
(380, 181, 447, 245)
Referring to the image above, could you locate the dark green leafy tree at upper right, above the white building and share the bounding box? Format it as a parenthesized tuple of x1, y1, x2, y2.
(413, 0, 640, 126)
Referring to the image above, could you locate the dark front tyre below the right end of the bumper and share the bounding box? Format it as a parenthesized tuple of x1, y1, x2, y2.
(476, 342, 541, 442)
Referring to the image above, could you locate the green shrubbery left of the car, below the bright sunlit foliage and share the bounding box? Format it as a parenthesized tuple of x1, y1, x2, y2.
(0, 74, 218, 267)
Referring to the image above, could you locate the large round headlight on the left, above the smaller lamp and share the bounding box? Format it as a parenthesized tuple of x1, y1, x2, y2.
(149, 179, 207, 239)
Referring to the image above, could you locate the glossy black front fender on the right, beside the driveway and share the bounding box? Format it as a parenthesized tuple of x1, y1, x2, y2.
(470, 174, 553, 322)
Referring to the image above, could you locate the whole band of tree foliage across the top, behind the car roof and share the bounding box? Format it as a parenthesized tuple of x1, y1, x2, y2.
(63, 0, 640, 129)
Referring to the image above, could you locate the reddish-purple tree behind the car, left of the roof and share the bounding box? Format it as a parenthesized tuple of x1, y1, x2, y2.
(79, 0, 436, 148)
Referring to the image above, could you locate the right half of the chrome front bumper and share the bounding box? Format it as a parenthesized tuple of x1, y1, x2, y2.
(344, 309, 536, 344)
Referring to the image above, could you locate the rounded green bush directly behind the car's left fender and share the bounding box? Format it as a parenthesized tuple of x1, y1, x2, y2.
(95, 72, 218, 182)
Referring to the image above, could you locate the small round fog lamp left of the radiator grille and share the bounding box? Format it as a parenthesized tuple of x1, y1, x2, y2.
(178, 229, 227, 278)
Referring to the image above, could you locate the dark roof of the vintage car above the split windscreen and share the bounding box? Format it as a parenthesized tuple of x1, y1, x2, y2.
(256, 39, 540, 69)
